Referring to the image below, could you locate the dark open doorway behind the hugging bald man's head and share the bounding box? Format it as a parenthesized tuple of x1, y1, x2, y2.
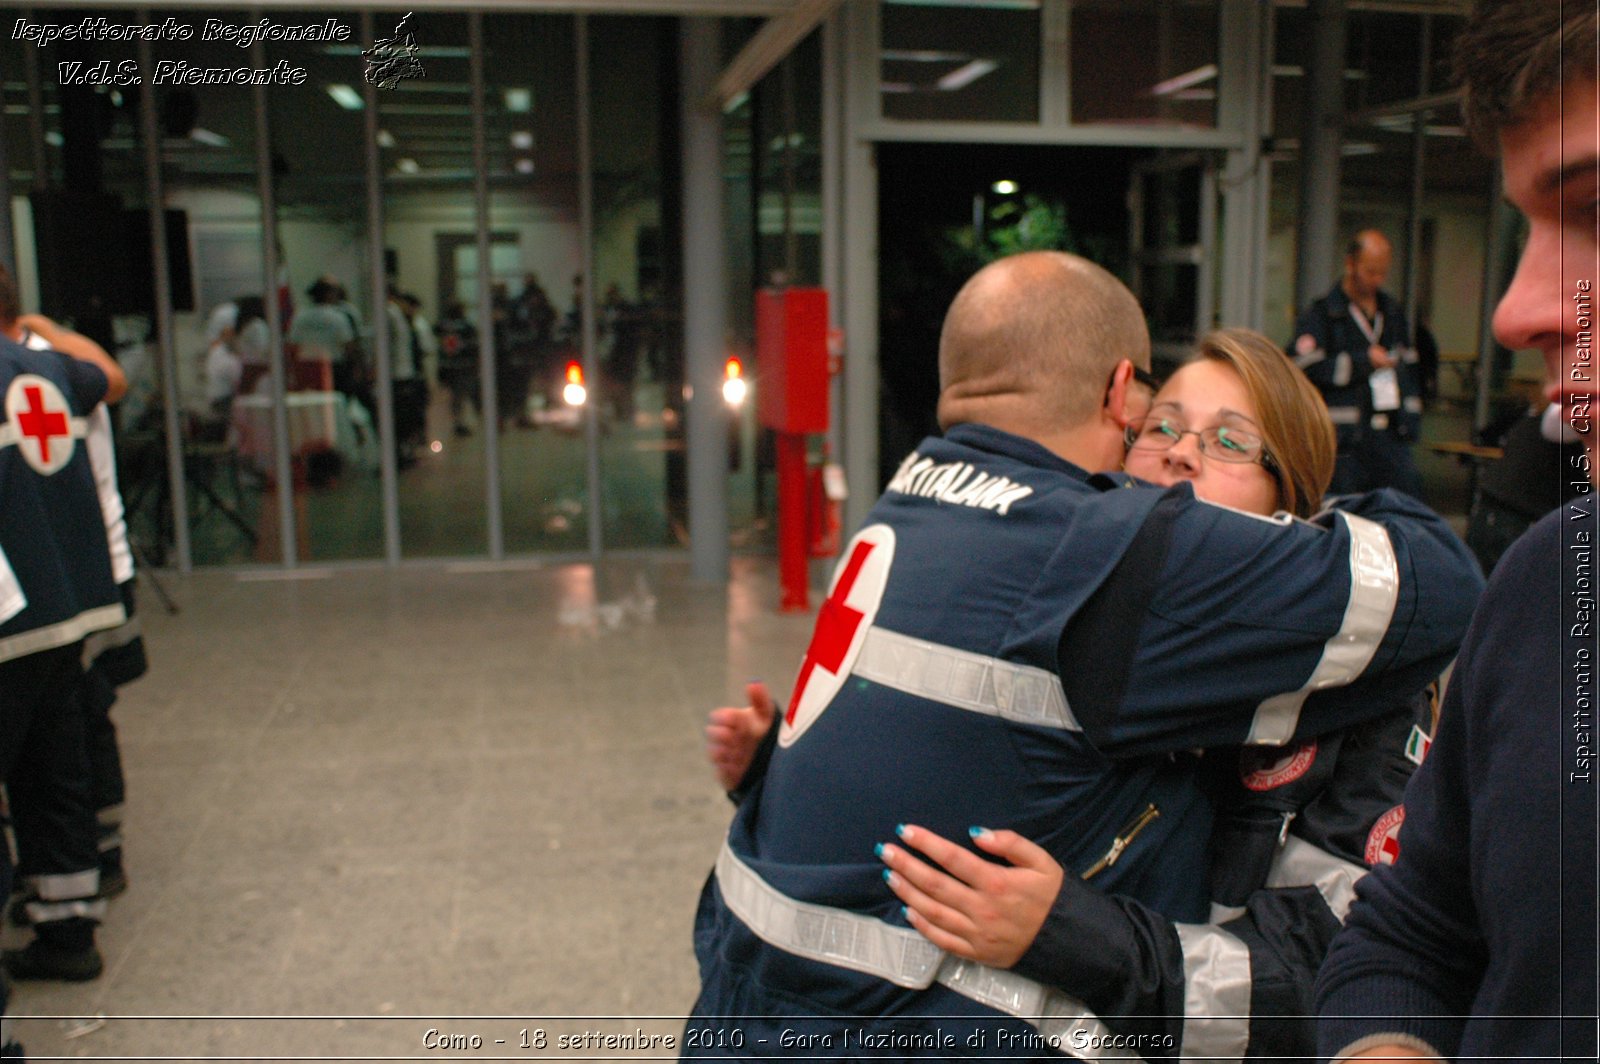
(877, 144, 1154, 485)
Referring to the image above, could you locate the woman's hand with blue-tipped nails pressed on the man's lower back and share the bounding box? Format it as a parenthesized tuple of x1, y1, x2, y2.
(878, 824, 1062, 968)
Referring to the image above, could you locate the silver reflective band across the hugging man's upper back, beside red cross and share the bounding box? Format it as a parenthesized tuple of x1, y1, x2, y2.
(851, 626, 1082, 731)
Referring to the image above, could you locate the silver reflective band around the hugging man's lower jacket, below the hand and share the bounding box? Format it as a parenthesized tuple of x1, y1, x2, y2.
(717, 840, 1141, 1061)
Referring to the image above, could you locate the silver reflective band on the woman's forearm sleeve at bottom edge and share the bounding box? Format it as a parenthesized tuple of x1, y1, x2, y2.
(1173, 923, 1250, 1061)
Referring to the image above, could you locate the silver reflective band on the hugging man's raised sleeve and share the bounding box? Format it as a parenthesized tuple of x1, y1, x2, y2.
(1245, 514, 1400, 746)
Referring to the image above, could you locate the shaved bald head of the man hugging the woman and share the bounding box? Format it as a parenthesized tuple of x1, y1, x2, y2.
(939, 251, 1150, 438)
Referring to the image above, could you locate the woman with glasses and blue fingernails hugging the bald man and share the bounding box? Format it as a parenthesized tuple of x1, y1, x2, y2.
(707, 330, 1432, 1058)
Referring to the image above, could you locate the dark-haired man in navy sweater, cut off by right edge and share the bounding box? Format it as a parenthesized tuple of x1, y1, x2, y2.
(1317, 0, 1600, 1061)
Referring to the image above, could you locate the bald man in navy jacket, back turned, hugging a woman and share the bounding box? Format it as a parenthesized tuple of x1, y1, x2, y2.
(685, 253, 1480, 1056)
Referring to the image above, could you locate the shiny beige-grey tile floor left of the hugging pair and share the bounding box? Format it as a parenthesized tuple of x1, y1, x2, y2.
(6, 558, 811, 1061)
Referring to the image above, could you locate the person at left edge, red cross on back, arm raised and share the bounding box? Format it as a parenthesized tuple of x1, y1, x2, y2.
(0, 312, 126, 1004)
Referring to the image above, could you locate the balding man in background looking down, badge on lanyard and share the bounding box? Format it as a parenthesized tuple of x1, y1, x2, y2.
(1290, 229, 1422, 499)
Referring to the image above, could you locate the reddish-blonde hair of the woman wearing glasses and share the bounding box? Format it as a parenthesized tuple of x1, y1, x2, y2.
(1195, 330, 1338, 517)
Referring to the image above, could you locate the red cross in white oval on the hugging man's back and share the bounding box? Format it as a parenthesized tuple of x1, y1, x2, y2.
(778, 525, 894, 746)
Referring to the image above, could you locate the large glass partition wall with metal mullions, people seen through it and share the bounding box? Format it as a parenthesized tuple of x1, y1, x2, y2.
(0, 6, 732, 568)
